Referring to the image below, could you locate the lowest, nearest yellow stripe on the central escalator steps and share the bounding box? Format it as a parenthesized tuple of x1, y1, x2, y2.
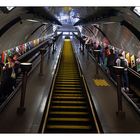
(47, 125, 91, 129)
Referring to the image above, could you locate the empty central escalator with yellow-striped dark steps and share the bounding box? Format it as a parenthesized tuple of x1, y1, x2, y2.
(41, 39, 100, 133)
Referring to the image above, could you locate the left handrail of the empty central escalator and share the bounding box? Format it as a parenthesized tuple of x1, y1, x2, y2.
(39, 37, 64, 133)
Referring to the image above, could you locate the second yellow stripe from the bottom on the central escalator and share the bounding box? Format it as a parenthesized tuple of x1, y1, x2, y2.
(49, 118, 89, 122)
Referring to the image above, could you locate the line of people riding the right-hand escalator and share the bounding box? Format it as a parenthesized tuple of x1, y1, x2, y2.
(80, 37, 129, 91)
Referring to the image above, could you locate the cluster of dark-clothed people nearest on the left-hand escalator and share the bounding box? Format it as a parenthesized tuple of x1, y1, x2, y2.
(0, 54, 19, 102)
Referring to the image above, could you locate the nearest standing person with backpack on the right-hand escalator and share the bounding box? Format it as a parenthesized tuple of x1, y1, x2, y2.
(116, 54, 129, 91)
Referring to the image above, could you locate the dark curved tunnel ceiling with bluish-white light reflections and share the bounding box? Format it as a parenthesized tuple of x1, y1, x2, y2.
(0, 6, 140, 35)
